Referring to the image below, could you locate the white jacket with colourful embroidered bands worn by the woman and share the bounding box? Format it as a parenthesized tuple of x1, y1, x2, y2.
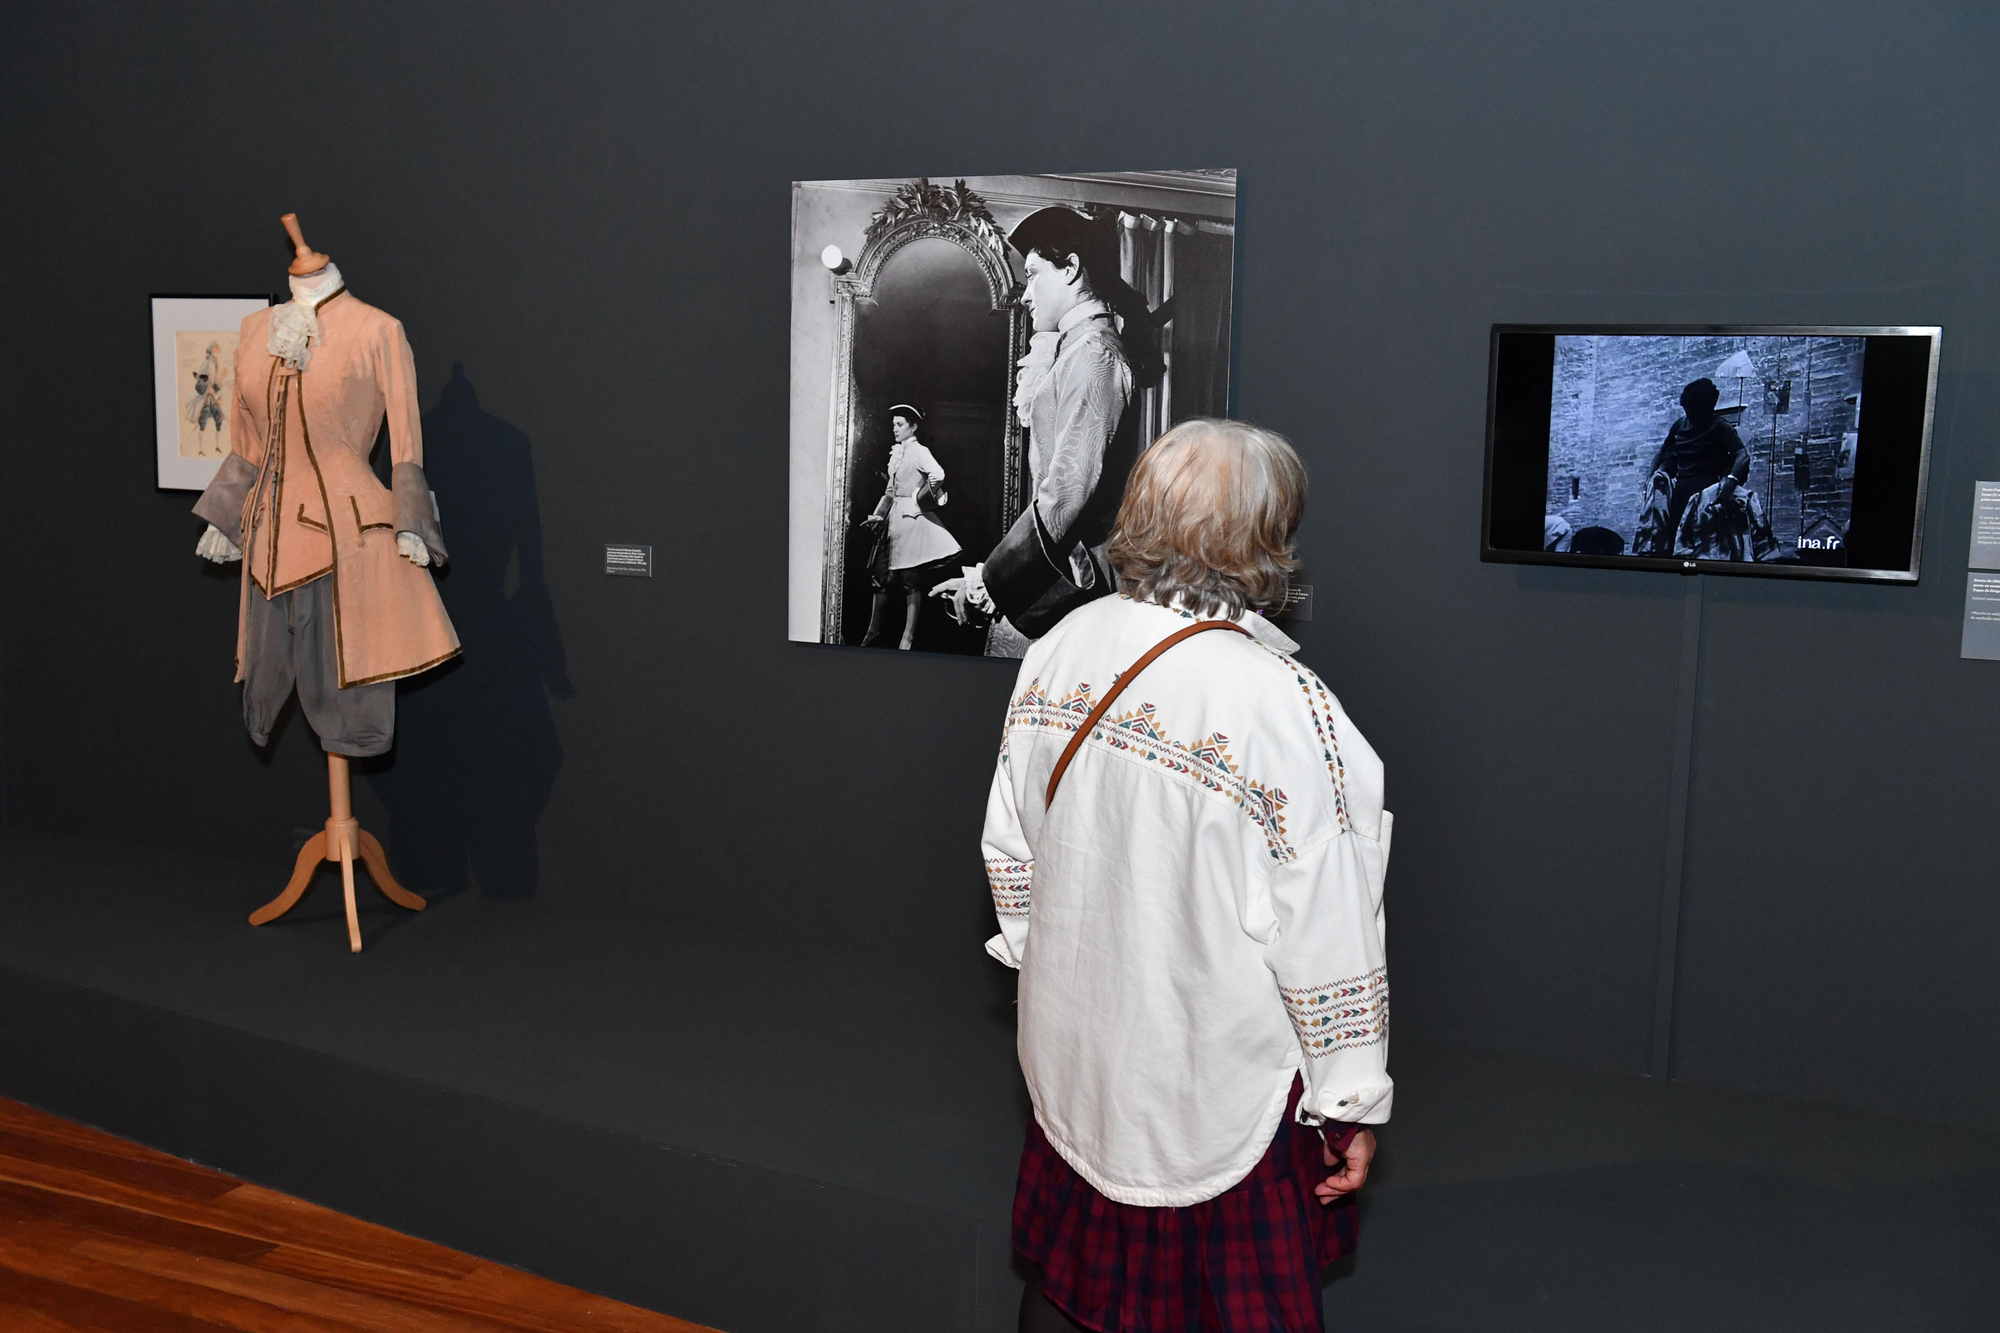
(984, 596, 1392, 1207)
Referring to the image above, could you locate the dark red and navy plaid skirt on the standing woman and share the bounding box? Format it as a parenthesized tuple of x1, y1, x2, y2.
(1014, 1079, 1356, 1333)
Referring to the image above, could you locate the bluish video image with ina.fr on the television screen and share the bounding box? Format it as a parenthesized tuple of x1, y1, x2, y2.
(1542, 334, 1866, 564)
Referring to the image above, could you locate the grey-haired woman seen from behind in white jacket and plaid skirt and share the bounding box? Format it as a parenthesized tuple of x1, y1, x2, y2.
(984, 420, 1392, 1333)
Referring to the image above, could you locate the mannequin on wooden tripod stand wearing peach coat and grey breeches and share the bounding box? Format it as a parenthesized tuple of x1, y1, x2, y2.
(194, 214, 458, 953)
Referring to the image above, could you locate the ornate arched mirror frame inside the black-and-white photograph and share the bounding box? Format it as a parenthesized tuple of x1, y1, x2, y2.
(820, 178, 1026, 642)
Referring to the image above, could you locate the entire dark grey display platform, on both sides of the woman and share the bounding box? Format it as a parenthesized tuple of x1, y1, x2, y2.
(0, 831, 2000, 1333)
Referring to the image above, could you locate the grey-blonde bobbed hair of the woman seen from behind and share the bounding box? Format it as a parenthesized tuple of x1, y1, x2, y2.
(1108, 416, 1306, 618)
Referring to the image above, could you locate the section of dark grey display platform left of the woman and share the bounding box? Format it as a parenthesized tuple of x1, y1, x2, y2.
(0, 833, 1008, 1333)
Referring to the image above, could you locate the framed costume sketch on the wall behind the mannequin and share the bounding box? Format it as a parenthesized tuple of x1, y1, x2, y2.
(152, 296, 270, 490)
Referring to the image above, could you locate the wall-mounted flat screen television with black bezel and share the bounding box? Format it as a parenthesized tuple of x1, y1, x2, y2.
(1480, 324, 1940, 582)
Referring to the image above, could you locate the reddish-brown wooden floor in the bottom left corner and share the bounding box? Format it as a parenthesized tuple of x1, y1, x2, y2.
(0, 1099, 708, 1333)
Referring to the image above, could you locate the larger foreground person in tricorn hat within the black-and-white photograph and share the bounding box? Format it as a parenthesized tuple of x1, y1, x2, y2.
(932, 208, 1140, 656)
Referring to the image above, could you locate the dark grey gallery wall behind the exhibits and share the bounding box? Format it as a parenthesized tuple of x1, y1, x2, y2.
(0, 0, 2000, 1125)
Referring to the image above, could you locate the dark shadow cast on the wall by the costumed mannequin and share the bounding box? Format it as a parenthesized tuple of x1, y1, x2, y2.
(368, 362, 576, 899)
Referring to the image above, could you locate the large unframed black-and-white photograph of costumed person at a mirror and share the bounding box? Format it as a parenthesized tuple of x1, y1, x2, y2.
(788, 168, 1236, 656)
